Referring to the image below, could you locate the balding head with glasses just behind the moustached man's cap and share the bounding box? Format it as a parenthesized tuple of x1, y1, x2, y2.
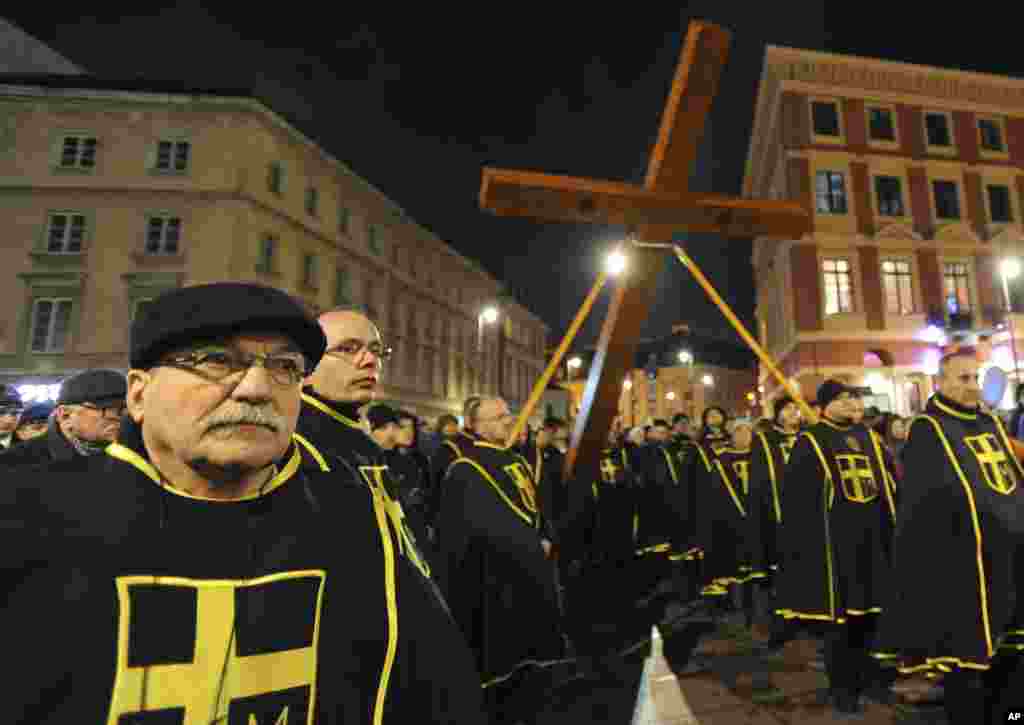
(309, 311, 386, 402)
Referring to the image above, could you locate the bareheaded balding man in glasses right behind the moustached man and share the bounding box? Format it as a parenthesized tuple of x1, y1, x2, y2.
(296, 307, 430, 578)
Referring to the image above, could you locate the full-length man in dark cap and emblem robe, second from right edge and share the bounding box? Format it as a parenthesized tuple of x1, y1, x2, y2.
(776, 380, 895, 714)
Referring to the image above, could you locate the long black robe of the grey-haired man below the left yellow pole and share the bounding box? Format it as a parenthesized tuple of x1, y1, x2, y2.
(439, 441, 562, 687)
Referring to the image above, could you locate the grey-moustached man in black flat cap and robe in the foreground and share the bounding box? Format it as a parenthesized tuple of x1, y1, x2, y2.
(0, 283, 482, 725)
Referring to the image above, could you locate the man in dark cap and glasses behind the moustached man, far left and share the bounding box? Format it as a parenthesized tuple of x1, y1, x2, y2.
(0, 370, 128, 466)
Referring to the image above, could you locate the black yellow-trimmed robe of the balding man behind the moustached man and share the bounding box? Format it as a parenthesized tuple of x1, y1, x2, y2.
(295, 388, 430, 578)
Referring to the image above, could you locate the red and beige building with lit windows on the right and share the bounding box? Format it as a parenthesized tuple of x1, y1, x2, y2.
(743, 47, 1024, 415)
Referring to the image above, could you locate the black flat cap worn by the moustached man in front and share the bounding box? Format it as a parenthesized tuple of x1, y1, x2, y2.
(131, 282, 327, 371)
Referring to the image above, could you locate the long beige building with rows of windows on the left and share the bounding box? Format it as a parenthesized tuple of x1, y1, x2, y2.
(0, 77, 548, 417)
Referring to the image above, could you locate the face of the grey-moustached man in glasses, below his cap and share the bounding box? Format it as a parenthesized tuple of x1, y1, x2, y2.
(128, 335, 305, 471)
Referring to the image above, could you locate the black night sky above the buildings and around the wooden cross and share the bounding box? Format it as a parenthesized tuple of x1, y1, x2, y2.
(4, 7, 1024, 362)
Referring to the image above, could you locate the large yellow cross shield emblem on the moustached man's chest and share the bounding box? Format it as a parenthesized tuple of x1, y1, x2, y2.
(106, 569, 326, 725)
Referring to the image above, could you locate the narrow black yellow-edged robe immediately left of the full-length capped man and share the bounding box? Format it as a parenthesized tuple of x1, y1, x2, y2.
(746, 427, 797, 573)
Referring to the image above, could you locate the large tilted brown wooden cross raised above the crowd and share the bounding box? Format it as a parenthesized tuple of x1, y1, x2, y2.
(480, 23, 810, 489)
